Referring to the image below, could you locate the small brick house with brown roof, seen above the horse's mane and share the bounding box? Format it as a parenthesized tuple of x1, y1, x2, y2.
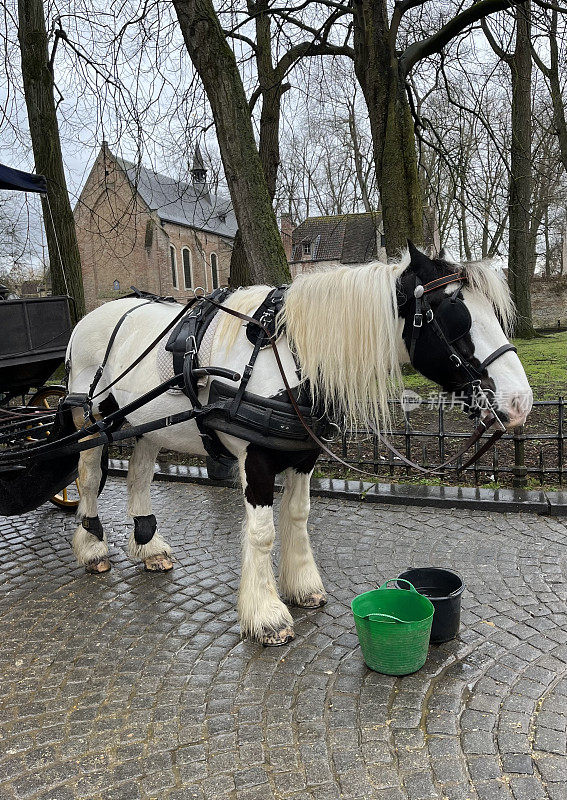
(288, 211, 386, 278)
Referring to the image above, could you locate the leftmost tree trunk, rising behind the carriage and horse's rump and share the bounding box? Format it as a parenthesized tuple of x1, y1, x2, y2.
(18, 0, 85, 322)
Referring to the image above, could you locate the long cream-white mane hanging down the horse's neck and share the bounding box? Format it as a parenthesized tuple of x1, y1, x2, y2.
(281, 262, 405, 429)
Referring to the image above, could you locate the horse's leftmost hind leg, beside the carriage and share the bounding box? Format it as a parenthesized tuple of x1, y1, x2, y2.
(73, 447, 110, 573)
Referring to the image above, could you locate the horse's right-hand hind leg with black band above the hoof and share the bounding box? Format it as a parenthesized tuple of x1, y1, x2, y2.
(126, 436, 173, 572)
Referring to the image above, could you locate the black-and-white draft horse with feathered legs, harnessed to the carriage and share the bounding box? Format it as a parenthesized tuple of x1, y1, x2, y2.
(67, 243, 533, 646)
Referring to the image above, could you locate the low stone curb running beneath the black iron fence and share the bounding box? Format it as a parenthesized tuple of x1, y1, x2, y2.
(109, 459, 567, 516)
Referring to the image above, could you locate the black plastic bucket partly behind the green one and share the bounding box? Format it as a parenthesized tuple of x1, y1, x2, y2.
(398, 567, 465, 644)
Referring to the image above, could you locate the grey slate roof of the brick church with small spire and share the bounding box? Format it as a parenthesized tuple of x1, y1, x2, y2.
(116, 158, 238, 239)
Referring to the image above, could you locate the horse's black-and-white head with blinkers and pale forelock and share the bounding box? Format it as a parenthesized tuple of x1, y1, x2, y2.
(398, 243, 533, 428)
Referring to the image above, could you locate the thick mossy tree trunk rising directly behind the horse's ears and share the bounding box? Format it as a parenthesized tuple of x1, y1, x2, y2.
(353, 0, 423, 258)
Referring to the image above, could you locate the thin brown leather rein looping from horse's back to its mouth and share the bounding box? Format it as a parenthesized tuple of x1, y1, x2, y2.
(206, 296, 506, 477)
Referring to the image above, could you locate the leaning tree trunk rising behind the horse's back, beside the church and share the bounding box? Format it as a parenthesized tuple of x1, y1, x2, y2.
(174, 0, 291, 284)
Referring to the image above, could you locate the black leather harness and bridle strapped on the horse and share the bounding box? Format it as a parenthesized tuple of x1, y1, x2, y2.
(81, 273, 516, 475)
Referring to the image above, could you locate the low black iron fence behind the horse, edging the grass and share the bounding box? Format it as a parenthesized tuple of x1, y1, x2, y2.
(112, 397, 567, 487)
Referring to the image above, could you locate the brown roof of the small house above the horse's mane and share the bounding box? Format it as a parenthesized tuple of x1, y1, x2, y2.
(291, 211, 382, 264)
